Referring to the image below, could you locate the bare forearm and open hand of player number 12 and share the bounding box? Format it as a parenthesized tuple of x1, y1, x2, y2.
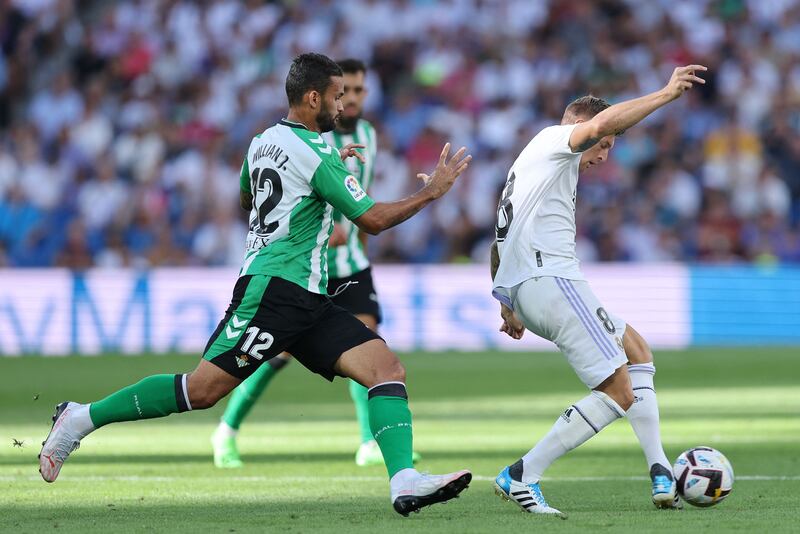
(353, 143, 472, 235)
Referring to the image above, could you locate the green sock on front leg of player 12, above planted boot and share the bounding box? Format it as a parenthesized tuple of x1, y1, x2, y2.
(369, 382, 414, 478)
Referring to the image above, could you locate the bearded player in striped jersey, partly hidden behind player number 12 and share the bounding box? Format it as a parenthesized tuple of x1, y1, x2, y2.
(211, 59, 419, 468)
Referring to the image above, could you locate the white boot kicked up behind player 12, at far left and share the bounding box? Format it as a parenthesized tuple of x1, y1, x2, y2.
(39, 402, 92, 482)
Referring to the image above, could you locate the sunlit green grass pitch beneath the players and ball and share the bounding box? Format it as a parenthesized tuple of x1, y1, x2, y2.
(0, 348, 800, 534)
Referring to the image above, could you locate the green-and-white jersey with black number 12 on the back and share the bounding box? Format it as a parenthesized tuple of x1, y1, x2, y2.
(239, 120, 375, 295)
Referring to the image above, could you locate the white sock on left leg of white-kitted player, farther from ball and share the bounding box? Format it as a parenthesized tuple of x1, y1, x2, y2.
(522, 391, 625, 484)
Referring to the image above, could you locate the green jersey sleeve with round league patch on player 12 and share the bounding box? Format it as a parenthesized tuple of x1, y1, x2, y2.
(311, 153, 375, 221)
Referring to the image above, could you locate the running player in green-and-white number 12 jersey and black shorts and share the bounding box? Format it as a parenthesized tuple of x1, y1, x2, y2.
(39, 54, 472, 515)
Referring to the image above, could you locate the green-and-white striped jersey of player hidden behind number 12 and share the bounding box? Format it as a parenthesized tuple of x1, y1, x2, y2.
(323, 119, 378, 278)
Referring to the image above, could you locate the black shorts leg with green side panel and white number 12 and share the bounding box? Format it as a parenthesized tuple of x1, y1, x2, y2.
(203, 275, 318, 380)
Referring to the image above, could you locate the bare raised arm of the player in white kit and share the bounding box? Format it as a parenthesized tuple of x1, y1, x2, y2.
(569, 65, 708, 152)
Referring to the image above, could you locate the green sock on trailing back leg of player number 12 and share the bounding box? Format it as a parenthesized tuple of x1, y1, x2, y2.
(89, 375, 191, 428)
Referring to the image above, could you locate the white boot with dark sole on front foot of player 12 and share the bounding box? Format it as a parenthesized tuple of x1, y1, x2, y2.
(391, 469, 472, 517)
